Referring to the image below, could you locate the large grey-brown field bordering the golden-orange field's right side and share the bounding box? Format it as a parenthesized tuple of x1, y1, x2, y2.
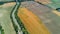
(22, 1, 60, 34)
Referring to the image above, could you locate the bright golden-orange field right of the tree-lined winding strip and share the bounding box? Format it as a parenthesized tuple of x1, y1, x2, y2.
(18, 8, 50, 34)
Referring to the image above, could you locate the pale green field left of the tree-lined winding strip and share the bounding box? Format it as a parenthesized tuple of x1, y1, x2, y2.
(0, 4, 16, 34)
